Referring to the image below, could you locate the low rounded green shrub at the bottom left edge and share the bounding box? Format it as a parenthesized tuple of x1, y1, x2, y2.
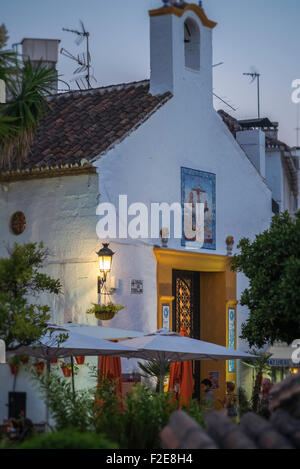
(15, 428, 118, 449)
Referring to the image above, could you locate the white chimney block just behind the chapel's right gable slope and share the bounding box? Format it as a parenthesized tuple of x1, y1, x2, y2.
(236, 129, 266, 178)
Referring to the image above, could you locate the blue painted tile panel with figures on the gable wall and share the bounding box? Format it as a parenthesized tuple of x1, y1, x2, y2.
(181, 168, 216, 249)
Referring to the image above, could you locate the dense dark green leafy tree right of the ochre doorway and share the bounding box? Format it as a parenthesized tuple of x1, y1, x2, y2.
(232, 212, 300, 348)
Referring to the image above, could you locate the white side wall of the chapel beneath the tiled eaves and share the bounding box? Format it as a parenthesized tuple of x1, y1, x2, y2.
(0, 174, 99, 422)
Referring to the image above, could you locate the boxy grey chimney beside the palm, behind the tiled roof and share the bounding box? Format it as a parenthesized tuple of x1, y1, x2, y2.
(21, 38, 60, 89)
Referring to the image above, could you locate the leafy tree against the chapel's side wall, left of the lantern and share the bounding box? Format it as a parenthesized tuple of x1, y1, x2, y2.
(0, 243, 61, 350)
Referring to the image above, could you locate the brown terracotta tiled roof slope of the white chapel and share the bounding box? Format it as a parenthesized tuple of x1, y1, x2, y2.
(3, 80, 172, 171)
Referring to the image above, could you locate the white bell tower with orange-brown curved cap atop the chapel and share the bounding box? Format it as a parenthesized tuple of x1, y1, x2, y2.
(149, 0, 216, 100)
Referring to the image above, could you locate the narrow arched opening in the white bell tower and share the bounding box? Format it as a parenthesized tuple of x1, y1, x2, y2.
(184, 19, 200, 70)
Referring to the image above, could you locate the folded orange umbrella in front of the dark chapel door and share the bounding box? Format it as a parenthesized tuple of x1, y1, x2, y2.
(169, 327, 194, 406)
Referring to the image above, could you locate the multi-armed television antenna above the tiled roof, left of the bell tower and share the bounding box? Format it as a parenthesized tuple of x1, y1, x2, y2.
(60, 20, 96, 89)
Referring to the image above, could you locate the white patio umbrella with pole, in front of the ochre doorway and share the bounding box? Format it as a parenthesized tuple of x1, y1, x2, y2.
(123, 329, 255, 392)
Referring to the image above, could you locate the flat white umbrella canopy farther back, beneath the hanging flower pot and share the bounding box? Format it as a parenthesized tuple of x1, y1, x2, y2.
(49, 322, 144, 340)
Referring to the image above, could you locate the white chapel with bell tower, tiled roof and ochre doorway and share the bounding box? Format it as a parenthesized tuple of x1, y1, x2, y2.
(0, 2, 296, 421)
